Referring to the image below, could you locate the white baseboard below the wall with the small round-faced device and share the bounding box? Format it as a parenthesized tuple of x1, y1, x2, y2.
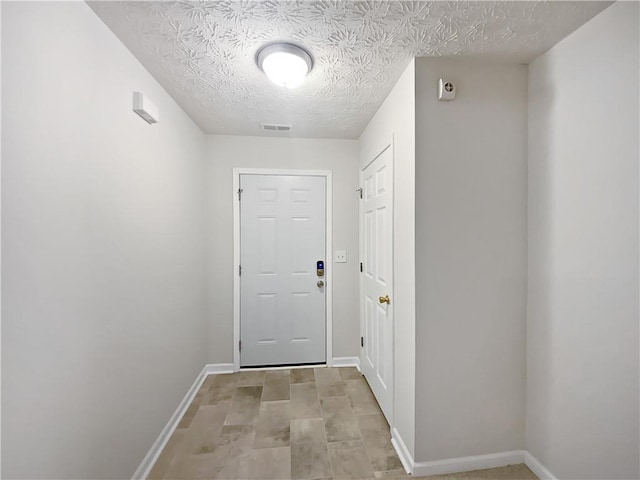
(412, 450, 525, 477)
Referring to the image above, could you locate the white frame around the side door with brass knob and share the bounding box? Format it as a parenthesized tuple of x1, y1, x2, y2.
(358, 135, 396, 429)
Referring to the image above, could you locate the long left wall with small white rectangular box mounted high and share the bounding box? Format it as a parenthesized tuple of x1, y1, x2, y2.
(2, 2, 207, 478)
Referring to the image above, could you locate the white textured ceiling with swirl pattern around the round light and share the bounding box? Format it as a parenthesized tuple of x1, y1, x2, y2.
(89, 0, 610, 138)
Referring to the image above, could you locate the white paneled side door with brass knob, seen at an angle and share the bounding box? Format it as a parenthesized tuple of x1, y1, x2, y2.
(360, 146, 393, 424)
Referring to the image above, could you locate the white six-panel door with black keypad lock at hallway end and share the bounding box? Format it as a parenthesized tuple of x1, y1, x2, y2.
(240, 174, 327, 367)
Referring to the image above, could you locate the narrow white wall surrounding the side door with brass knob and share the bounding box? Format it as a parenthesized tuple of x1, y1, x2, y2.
(359, 61, 416, 456)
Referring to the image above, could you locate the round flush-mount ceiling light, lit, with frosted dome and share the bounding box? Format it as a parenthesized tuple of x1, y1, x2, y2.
(256, 43, 313, 88)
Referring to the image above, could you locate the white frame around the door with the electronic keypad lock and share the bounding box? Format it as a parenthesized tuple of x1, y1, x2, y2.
(232, 168, 333, 372)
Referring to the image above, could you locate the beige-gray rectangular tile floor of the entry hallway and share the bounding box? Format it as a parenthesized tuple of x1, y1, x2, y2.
(149, 368, 536, 480)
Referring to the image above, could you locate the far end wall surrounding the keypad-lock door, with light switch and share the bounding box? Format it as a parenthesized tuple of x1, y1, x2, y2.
(207, 135, 360, 363)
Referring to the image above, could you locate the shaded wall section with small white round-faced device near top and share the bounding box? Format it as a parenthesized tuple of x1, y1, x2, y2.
(415, 58, 527, 462)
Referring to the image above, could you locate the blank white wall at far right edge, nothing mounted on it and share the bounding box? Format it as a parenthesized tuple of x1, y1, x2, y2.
(526, 2, 640, 479)
